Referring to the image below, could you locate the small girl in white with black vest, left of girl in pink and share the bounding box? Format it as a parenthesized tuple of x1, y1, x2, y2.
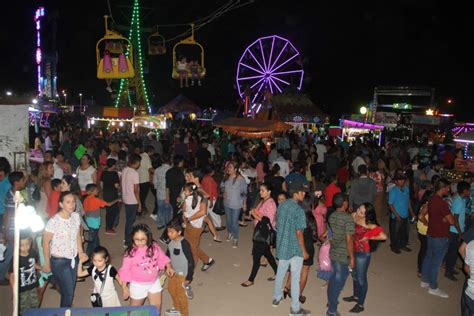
(77, 246, 130, 307)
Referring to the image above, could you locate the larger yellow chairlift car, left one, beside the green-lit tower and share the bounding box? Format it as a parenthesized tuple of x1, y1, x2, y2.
(95, 15, 135, 79)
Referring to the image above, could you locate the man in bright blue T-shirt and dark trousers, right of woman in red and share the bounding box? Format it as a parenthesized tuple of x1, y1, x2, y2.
(388, 174, 415, 254)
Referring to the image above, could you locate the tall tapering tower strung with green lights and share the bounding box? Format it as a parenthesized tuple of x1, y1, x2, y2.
(115, 0, 150, 109)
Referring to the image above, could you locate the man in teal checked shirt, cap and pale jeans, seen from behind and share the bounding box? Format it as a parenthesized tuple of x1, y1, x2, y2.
(272, 181, 310, 315)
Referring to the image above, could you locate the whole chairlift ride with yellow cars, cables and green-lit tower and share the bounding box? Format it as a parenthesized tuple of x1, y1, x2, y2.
(96, 0, 253, 116)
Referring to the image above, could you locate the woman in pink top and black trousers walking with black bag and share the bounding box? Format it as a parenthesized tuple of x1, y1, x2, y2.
(241, 183, 277, 287)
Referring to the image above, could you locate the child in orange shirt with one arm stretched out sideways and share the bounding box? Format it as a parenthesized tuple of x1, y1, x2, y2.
(84, 183, 120, 258)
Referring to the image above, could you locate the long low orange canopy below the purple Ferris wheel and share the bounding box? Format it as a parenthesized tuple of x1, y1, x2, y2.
(214, 117, 292, 133)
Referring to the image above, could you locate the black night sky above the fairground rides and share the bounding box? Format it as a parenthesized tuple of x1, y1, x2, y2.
(0, 0, 474, 120)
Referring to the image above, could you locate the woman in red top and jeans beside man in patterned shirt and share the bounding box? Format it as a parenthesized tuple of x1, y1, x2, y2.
(343, 203, 387, 313)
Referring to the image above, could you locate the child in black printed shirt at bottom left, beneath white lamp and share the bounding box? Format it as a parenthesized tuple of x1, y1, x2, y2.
(9, 231, 41, 315)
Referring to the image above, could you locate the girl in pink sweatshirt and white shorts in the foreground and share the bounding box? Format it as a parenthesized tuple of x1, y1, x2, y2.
(119, 224, 174, 311)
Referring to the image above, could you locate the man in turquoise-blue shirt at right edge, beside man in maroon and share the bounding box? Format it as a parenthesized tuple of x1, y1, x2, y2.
(444, 181, 471, 281)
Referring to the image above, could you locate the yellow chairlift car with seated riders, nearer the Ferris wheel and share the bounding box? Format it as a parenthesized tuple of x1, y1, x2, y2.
(171, 24, 206, 79)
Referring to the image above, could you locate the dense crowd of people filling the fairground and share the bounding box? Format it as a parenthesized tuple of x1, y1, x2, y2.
(0, 122, 474, 315)
